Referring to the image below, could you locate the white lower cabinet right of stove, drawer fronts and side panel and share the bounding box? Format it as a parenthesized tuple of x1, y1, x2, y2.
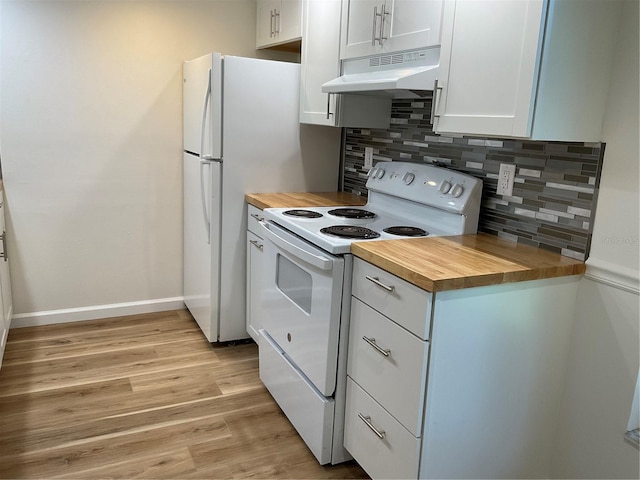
(344, 258, 580, 479)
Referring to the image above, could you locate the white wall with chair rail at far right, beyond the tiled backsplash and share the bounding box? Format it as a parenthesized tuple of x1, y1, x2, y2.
(551, 0, 640, 478)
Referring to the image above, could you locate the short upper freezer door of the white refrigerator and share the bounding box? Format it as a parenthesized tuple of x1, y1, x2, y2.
(182, 53, 222, 160)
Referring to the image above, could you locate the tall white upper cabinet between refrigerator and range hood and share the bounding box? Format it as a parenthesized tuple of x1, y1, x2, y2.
(300, 0, 391, 128)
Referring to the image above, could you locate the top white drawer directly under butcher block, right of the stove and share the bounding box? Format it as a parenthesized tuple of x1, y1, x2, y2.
(352, 258, 433, 340)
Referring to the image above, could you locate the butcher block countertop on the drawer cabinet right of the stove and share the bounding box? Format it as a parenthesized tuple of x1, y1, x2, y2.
(351, 233, 585, 292)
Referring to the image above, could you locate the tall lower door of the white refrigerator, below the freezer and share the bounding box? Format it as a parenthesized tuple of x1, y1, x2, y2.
(183, 153, 222, 342)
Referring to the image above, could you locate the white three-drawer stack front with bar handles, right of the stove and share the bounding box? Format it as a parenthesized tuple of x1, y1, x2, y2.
(345, 258, 433, 478)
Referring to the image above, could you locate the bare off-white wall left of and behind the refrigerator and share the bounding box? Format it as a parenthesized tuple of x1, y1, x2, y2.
(0, 0, 298, 324)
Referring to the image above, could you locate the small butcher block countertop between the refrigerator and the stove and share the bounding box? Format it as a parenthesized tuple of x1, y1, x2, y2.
(244, 192, 367, 209)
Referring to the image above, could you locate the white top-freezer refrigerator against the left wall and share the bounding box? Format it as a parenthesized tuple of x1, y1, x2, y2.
(183, 53, 340, 342)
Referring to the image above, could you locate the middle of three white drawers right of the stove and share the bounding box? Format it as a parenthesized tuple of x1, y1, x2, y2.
(347, 298, 429, 437)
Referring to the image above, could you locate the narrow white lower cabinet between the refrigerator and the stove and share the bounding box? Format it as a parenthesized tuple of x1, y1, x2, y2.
(247, 205, 263, 343)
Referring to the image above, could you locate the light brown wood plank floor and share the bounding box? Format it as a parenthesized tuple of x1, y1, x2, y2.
(0, 310, 368, 479)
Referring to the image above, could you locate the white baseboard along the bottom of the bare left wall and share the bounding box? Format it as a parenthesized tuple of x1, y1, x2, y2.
(11, 297, 185, 328)
